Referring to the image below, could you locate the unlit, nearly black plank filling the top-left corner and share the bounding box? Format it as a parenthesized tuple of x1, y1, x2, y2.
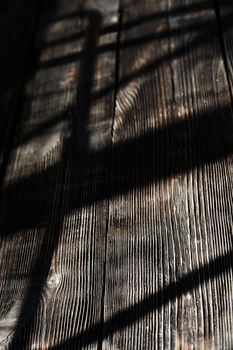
(0, 0, 40, 182)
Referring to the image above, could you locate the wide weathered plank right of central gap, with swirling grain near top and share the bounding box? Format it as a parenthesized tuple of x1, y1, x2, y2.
(103, 0, 233, 349)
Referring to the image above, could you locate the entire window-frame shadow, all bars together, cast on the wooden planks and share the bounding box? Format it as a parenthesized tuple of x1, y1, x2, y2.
(1, 2, 233, 349)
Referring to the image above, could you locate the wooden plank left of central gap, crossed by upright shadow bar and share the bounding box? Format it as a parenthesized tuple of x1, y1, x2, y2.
(0, 0, 118, 349)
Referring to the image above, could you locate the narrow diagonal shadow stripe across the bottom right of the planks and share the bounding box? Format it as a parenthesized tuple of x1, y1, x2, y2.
(51, 251, 233, 350)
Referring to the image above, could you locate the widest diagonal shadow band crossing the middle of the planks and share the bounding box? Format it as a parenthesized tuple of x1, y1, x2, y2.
(0, 106, 233, 237)
